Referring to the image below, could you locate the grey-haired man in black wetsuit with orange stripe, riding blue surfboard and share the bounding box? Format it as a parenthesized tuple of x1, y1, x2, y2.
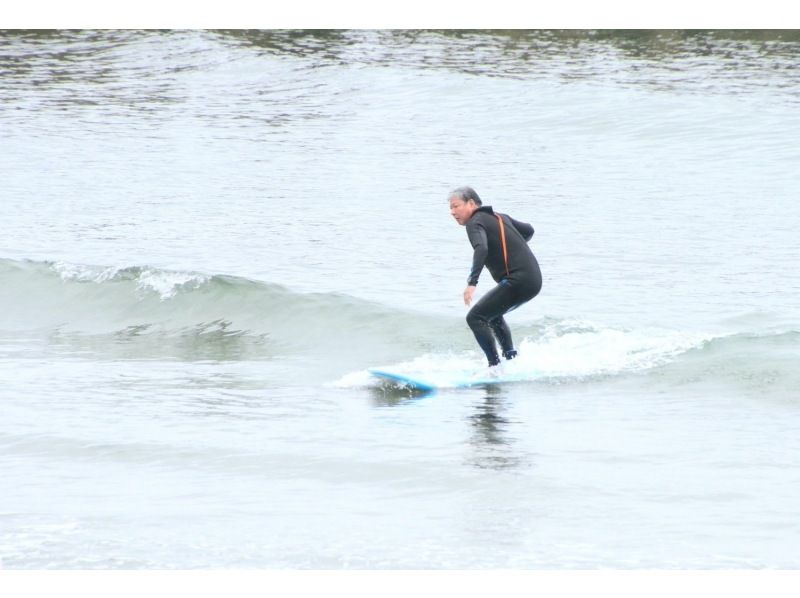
(449, 187, 542, 367)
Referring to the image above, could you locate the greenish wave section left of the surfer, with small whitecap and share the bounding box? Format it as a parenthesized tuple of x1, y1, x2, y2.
(0, 259, 453, 358)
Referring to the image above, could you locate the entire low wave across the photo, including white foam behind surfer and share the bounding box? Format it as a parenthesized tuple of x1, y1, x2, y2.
(0, 259, 800, 393)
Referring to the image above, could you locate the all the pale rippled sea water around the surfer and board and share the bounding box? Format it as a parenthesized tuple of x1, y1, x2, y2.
(0, 31, 800, 569)
